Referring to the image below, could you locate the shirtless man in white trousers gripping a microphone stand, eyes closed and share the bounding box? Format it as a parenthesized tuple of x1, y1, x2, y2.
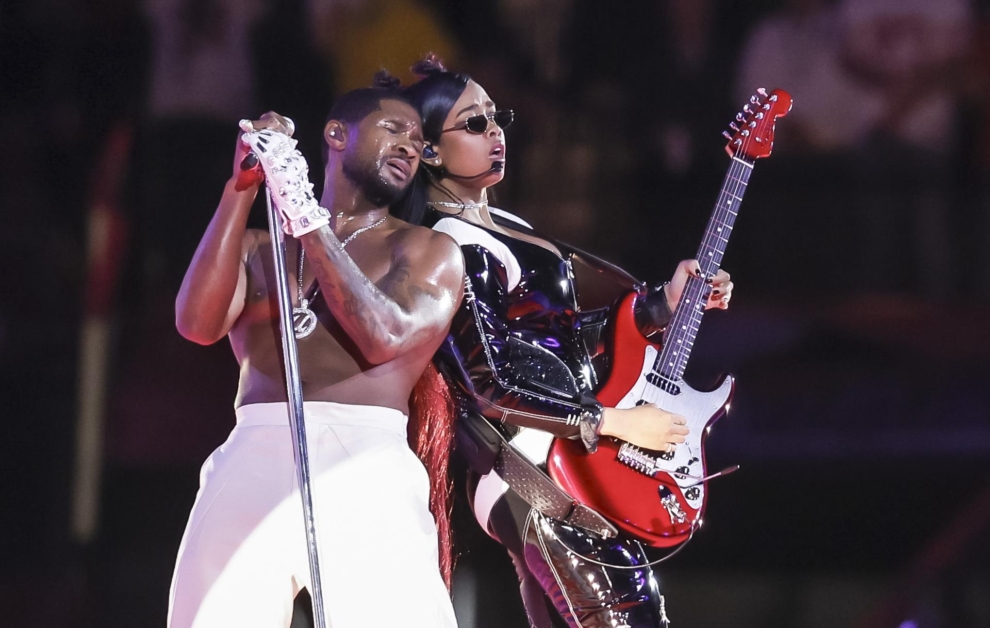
(168, 87, 463, 628)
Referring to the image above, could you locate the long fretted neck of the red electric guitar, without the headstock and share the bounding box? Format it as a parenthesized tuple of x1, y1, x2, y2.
(653, 157, 753, 381)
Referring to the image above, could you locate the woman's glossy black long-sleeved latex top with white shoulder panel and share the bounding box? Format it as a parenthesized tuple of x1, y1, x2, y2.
(426, 211, 670, 438)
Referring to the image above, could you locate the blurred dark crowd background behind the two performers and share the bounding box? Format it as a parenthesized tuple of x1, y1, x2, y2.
(0, 0, 990, 628)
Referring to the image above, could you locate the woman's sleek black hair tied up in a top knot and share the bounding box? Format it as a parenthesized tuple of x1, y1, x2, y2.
(392, 53, 471, 225)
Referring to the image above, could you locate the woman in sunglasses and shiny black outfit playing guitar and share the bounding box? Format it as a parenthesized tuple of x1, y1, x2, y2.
(400, 56, 732, 628)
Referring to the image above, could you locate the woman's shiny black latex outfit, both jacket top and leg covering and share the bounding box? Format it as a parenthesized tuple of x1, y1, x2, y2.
(426, 211, 669, 628)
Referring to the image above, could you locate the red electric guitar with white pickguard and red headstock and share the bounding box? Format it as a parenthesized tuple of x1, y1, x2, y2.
(547, 89, 791, 547)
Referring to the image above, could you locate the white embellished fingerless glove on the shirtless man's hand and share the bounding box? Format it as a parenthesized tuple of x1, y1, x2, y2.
(241, 129, 330, 238)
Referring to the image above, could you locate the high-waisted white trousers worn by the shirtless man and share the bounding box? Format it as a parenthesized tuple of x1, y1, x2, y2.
(168, 402, 456, 628)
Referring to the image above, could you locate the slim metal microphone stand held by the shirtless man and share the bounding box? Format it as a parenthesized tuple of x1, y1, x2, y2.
(265, 181, 327, 628)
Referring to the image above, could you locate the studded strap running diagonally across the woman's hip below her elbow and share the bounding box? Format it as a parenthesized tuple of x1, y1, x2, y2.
(458, 412, 618, 539)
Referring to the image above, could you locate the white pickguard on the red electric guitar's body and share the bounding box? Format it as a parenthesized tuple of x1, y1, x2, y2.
(615, 345, 733, 509)
